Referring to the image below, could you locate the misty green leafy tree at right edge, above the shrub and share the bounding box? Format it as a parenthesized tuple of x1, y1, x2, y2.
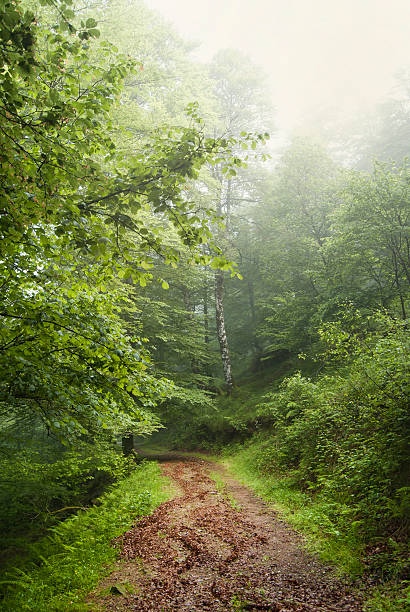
(326, 161, 410, 319)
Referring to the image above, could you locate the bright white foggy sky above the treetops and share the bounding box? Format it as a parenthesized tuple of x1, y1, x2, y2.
(146, 0, 410, 129)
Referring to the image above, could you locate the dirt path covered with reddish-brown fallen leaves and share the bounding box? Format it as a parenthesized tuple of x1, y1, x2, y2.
(89, 457, 362, 612)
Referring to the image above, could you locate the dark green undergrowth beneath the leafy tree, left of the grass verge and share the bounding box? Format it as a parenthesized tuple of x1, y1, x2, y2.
(0, 434, 135, 552)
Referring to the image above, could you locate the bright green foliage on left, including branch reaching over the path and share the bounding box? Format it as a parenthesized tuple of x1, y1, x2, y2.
(0, 0, 250, 443)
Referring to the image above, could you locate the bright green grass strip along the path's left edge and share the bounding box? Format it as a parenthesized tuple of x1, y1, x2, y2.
(1, 461, 170, 612)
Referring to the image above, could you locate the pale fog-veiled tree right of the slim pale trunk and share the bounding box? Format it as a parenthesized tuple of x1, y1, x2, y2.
(251, 139, 342, 351)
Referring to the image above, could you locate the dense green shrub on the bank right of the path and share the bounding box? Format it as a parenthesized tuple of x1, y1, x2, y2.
(257, 315, 410, 535)
